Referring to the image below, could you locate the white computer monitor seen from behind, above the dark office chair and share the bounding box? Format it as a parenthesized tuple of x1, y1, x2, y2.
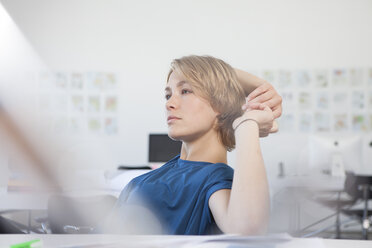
(308, 134, 362, 177)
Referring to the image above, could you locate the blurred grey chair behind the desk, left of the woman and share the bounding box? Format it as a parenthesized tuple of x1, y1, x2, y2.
(37, 195, 117, 234)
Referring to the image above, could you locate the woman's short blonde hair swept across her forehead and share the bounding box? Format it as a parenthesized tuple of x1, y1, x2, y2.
(167, 55, 245, 151)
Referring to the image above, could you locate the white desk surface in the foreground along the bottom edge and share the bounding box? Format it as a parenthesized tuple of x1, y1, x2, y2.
(0, 234, 372, 248)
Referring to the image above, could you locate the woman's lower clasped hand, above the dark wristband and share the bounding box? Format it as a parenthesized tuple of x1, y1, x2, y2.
(233, 105, 278, 137)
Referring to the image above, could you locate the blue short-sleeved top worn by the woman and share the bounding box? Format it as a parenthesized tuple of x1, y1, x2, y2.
(117, 155, 234, 235)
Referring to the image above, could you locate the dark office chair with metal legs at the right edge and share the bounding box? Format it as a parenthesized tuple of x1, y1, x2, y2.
(316, 172, 372, 239)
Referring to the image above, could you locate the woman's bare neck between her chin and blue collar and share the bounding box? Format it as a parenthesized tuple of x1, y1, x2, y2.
(180, 131, 227, 164)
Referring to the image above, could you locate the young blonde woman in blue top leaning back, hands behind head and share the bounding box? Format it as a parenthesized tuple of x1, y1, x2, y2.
(109, 56, 282, 235)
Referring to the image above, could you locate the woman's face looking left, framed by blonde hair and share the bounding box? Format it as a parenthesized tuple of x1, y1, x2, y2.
(165, 72, 218, 142)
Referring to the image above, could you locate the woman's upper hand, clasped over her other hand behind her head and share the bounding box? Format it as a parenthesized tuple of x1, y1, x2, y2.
(243, 82, 282, 118)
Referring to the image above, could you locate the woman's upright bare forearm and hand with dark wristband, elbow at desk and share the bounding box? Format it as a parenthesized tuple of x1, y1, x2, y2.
(209, 107, 274, 235)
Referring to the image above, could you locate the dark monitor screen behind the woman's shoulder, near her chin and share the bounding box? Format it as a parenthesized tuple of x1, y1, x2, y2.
(149, 134, 182, 162)
